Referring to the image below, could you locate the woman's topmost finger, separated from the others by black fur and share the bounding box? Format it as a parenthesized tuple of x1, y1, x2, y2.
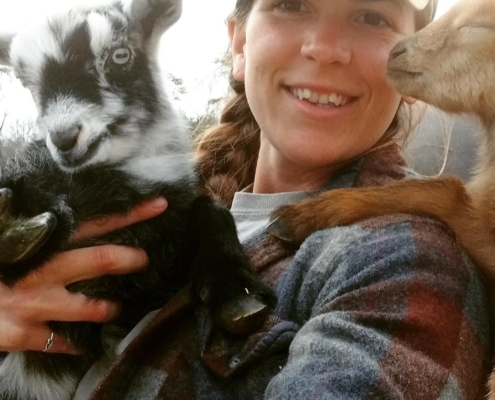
(72, 197, 168, 240)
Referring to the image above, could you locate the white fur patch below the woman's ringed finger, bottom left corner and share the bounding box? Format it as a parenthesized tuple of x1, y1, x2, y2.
(0, 353, 78, 400)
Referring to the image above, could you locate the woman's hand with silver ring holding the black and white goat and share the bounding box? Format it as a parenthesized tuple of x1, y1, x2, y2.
(0, 198, 167, 354)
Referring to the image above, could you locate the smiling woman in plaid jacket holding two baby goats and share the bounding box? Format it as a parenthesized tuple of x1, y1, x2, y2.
(0, 0, 489, 400)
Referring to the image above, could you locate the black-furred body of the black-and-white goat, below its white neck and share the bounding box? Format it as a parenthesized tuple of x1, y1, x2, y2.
(0, 143, 271, 394)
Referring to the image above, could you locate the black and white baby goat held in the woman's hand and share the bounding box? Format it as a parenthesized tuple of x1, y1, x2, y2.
(0, 0, 275, 400)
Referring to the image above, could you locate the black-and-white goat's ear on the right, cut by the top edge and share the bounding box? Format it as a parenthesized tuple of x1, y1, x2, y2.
(124, 0, 182, 49)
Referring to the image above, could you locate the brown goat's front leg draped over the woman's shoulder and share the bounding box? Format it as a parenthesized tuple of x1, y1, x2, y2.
(267, 176, 495, 282)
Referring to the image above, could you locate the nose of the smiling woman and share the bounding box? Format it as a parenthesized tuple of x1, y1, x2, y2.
(301, 22, 352, 64)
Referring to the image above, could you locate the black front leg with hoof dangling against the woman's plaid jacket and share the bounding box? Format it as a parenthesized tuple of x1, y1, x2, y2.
(192, 196, 276, 334)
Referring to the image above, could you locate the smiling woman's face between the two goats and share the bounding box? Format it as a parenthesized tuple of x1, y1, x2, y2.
(229, 0, 415, 191)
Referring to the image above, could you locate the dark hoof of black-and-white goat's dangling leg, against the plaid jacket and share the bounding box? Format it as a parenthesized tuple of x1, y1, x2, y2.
(217, 294, 271, 335)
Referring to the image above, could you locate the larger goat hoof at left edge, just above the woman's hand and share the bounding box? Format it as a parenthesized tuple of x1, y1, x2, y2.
(0, 212, 57, 264)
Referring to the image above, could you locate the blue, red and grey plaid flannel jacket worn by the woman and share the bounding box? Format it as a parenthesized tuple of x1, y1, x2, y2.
(83, 147, 490, 400)
